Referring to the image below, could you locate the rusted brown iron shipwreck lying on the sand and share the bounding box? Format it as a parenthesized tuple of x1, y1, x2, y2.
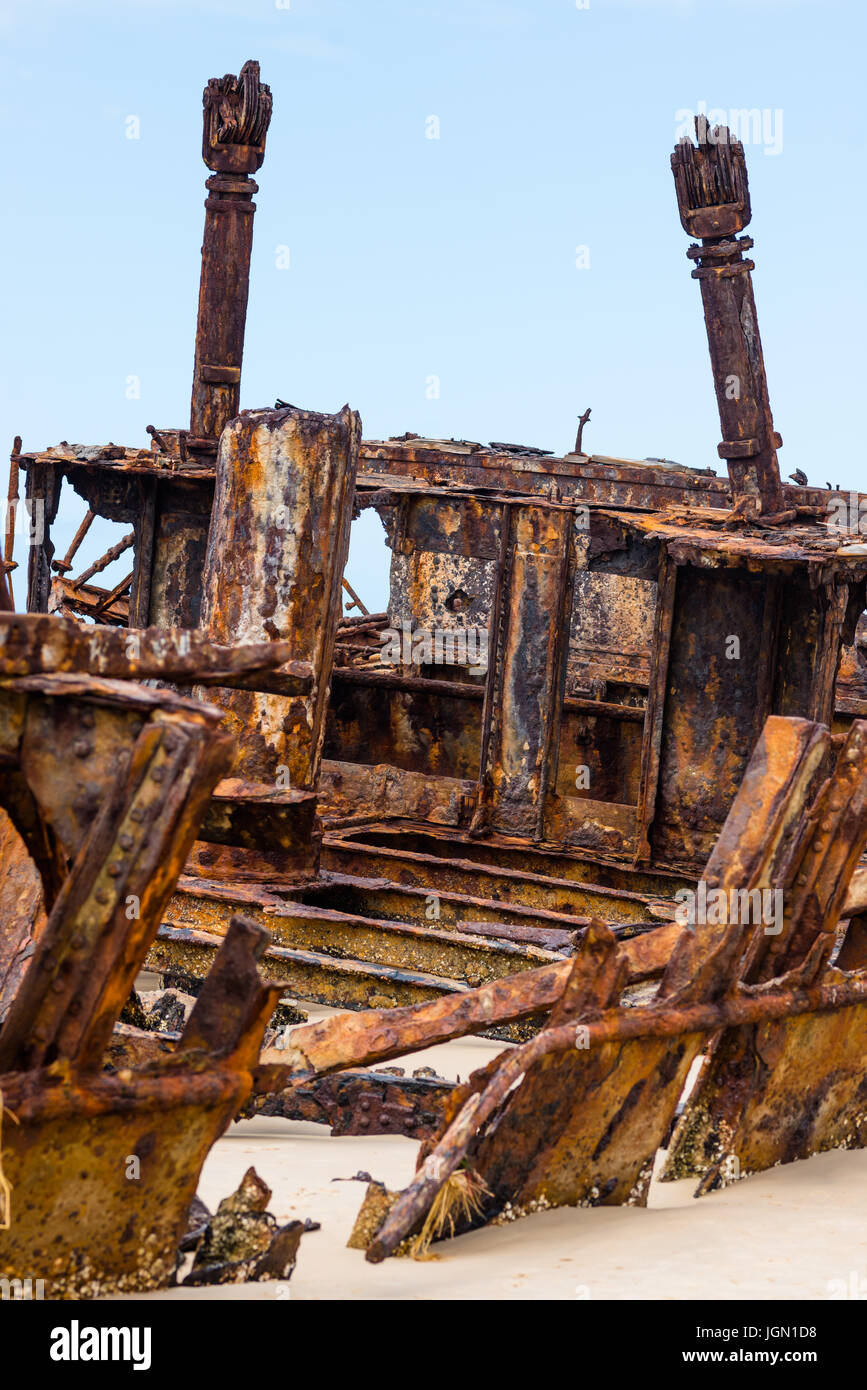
(0, 63, 867, 1297)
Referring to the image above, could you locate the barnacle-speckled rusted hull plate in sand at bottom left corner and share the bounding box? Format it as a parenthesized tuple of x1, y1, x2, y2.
(0, 1065, 249, 1298)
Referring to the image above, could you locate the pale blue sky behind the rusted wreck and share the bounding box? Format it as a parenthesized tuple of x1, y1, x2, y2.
(0, 0, 867, 606)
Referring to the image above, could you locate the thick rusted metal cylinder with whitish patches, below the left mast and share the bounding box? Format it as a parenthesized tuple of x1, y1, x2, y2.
(201, 407, 361, 791)
